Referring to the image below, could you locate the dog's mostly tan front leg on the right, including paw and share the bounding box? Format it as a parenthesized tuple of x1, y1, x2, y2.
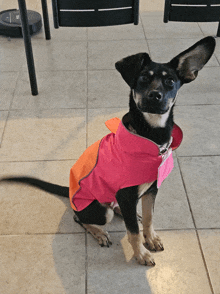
(142, 182, 164, 251)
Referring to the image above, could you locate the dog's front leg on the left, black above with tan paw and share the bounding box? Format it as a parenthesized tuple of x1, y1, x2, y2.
(116, 186, 155, 265)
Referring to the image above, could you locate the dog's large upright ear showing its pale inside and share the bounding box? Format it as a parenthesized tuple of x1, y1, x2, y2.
(170, 37, 215, 83)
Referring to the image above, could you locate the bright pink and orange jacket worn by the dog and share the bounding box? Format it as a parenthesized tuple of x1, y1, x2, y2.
(69, 118, 183, 211)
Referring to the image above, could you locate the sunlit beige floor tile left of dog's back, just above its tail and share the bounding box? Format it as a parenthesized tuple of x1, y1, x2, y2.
(0, 109, 86, 161)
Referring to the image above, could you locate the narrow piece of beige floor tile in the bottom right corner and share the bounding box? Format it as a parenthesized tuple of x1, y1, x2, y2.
(198, 230, 220, 293)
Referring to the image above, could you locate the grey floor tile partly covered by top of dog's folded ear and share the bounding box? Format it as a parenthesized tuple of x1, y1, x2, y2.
(88, 40, 148, 70)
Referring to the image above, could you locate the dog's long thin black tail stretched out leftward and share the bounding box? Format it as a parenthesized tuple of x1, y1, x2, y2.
(0, 177, 69, 197)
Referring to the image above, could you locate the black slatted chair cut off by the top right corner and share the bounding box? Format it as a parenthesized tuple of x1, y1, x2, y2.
(164, 0, 220, 37)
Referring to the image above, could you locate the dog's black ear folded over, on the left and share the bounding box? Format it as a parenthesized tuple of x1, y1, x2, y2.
(115, 53, 151, 89)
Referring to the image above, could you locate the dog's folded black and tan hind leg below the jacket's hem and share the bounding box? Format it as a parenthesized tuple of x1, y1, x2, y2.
(74, 200, 114, 247)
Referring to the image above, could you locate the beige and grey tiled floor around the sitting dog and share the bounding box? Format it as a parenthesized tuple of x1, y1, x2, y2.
(0, 0, 220, 294)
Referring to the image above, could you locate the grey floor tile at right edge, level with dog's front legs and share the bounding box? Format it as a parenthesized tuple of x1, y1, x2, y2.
(179, 156, 220, 228)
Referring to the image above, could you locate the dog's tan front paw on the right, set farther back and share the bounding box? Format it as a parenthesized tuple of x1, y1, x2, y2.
(144, 227, 164, 251)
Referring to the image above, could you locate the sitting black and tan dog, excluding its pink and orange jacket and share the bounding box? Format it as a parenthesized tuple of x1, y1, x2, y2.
(1, 37, 215, 265)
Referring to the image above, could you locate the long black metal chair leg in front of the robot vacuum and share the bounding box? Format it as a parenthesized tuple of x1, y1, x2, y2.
(18, 0, 38, 95)
